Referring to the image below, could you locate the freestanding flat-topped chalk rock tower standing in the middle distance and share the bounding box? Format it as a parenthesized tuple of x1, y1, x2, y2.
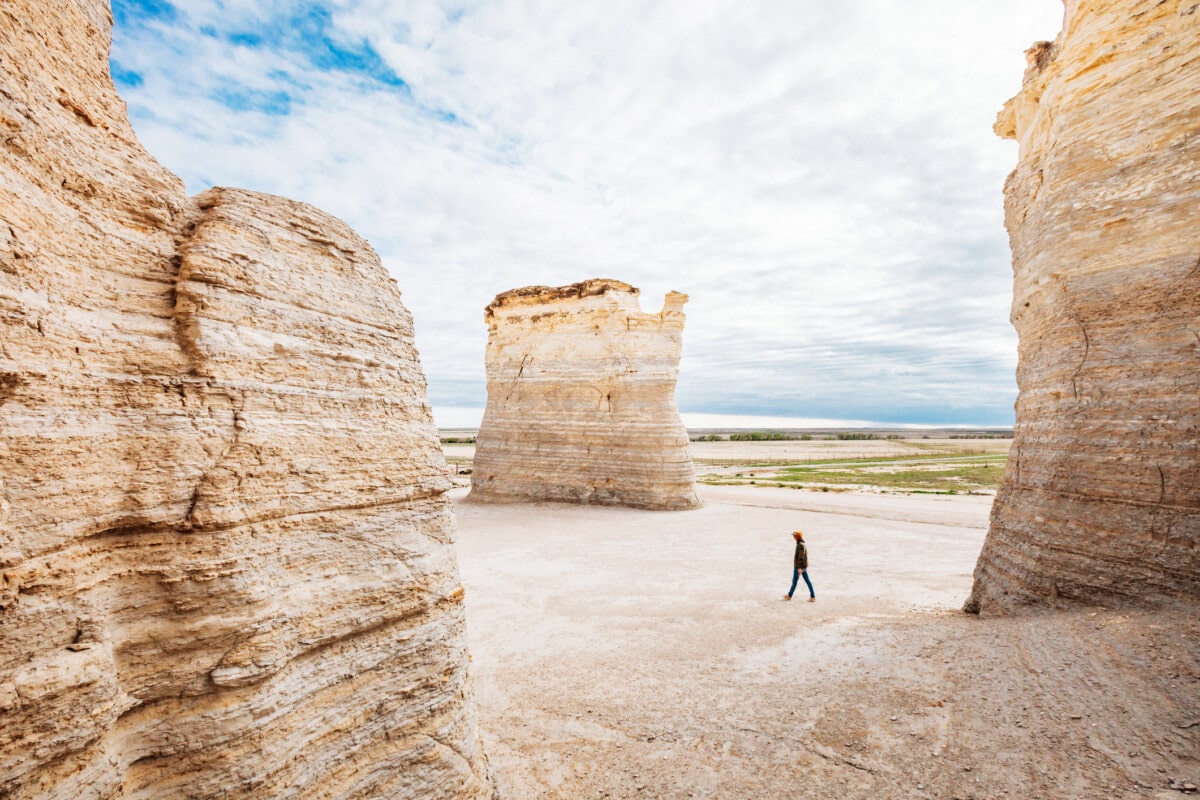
(470, 279, 700, 509)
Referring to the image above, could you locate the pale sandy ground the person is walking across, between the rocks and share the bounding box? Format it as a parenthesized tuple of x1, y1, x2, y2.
(455, 487, 1200, 800)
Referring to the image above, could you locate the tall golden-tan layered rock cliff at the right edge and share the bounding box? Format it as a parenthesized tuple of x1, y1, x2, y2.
(967, 0, 1200, 612)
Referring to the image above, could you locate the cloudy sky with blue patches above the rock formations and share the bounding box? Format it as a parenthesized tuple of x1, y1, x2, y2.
(110, 0, 1062, 426)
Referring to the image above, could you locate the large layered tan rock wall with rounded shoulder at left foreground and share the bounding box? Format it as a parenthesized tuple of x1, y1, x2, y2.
(0, 0, 491, 799)
